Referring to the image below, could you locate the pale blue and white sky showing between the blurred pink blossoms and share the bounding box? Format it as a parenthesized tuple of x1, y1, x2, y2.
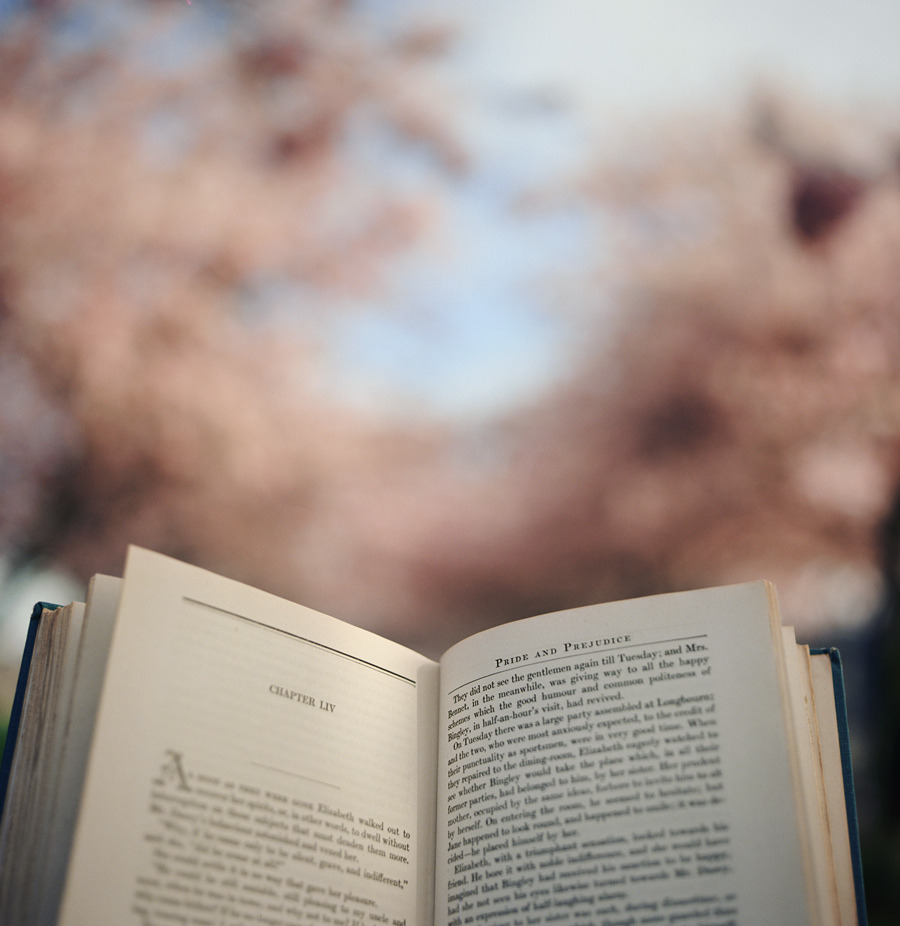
(325, 0, 900, 421)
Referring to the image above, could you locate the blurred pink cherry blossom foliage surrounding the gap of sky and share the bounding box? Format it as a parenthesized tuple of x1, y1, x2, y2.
(0, 0, 900, 650)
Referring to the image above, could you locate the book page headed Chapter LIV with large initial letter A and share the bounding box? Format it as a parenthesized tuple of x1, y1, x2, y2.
(59, 549, 437, 926)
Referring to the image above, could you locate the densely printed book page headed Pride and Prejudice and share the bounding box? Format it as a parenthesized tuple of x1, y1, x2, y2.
(435, 582, 831, 926)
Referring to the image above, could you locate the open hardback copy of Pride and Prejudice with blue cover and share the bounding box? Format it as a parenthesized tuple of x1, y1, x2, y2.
(0, 548, 864, 926)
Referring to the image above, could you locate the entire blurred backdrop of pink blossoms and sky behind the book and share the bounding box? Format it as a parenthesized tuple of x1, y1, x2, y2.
(0, 0, 900, 924)
